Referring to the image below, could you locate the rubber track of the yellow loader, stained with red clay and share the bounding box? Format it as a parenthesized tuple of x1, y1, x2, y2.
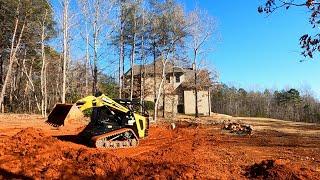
(91, 128, 139, 149)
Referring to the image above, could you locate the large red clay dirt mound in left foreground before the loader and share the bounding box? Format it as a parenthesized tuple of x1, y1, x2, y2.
(0, 128, 195, 179)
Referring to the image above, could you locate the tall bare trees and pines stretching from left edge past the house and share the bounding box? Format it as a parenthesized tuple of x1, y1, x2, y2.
(0, 0, 215, 121)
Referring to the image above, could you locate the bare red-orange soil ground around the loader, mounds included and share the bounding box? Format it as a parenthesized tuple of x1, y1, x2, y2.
(0, 114, 320, 179)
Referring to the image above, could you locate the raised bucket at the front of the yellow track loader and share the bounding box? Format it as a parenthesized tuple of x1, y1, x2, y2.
(46, 104, 84, 127)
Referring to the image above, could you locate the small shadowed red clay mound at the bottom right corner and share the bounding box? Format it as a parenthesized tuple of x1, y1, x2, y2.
(245, 160, 312, 180)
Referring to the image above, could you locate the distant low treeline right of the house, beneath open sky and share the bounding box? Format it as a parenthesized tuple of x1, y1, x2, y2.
(212, 85, 320, 123)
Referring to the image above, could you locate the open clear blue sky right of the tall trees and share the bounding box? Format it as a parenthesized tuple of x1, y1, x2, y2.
(181, 0, 320, 98)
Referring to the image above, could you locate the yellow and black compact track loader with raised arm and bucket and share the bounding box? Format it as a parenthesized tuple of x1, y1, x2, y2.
(46, 94, 149, 148)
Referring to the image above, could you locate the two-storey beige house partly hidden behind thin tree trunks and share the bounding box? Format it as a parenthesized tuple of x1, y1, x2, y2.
(125, 60, 211, 115)
